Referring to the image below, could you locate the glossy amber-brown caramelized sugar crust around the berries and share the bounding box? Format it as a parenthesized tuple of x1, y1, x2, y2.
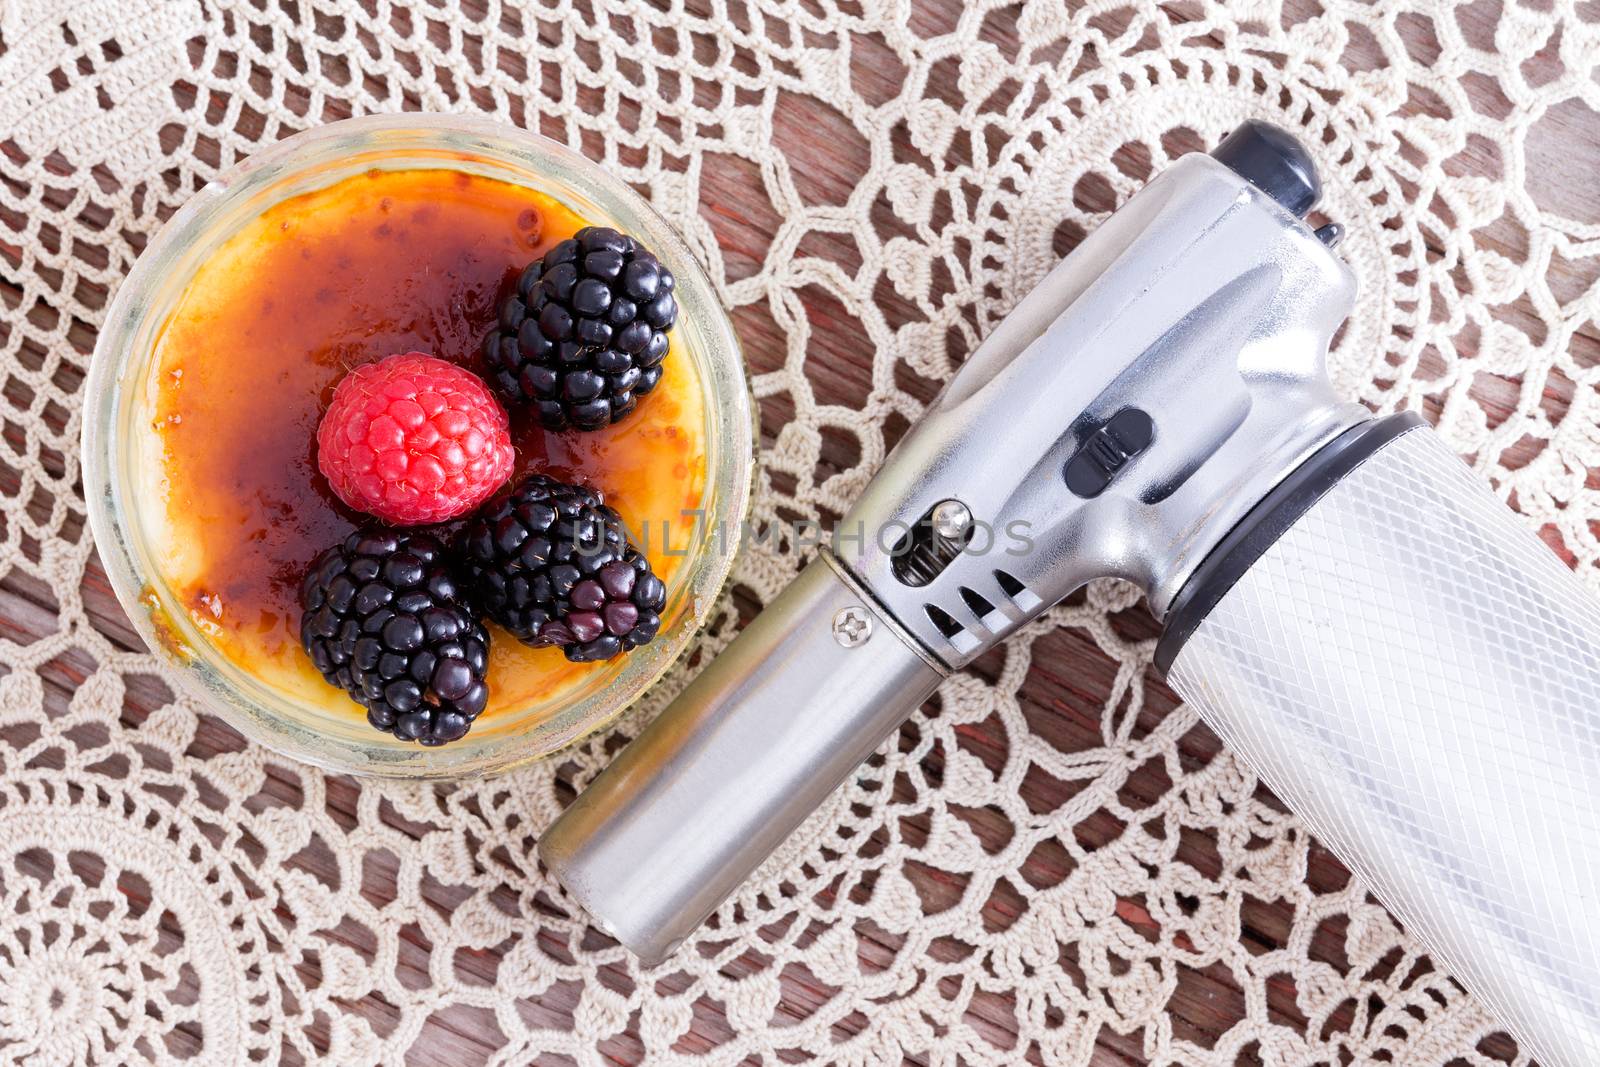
(155, 170, 706, 715)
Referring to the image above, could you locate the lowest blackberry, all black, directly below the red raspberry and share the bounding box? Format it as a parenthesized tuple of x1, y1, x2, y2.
(301, 530, 490, 745)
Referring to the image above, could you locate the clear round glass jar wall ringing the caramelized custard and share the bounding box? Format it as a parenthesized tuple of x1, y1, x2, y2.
(83, 115, 755, 777)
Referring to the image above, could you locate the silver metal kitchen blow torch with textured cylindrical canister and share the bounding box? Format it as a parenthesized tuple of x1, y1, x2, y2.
(539, 122, 1600, 1067)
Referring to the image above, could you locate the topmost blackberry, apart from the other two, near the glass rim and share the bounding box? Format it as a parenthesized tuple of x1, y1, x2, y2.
(483, 226, 678, 430)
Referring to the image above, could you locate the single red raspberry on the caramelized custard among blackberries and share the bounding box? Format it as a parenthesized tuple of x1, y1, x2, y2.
(317, 352, 512, 526)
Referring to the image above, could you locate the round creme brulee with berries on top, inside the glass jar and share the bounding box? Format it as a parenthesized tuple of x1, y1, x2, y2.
(142, 170, 707, 744)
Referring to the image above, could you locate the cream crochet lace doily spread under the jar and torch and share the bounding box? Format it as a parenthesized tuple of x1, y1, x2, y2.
(0, 0, 1600, 1065)
